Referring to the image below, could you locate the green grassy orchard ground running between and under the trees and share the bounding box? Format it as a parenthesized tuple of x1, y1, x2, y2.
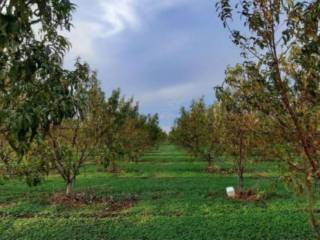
(0, 145, 314, 240)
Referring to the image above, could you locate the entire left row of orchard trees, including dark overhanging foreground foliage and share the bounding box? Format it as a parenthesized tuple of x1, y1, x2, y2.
(0, 0, 164, 194)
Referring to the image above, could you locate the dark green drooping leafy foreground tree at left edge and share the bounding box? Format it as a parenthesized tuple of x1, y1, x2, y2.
(0, 0, 100, 189)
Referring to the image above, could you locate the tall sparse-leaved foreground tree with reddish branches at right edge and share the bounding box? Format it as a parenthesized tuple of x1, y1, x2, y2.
(217, 0, 320, 232)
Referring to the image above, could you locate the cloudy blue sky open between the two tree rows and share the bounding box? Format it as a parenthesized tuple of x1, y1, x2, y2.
(65, 0, 240, 131)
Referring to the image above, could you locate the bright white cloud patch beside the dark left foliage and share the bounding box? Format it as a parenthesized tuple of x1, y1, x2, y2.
(65, 0, 191, 62)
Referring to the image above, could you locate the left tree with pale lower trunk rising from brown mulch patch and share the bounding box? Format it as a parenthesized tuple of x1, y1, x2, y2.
(47, 62, 97, 196)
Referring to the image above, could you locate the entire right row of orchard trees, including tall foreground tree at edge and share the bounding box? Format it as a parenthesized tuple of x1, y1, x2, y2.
(172, 0, 320, 238)
